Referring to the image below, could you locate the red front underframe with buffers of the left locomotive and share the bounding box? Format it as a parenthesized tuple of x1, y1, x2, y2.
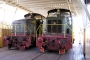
(4, 36, 35, 50)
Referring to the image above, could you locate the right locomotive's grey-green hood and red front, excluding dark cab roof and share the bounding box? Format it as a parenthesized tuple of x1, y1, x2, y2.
(36, 8, 72, 54)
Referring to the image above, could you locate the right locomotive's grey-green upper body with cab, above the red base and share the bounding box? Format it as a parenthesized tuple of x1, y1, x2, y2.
(46, 9, 72, 34)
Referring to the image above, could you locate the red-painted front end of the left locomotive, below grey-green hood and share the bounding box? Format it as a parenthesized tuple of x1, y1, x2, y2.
(3, 34, 35, 50)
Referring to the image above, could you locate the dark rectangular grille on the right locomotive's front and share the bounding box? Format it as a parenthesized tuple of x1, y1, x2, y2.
(47, 20, 62, 33)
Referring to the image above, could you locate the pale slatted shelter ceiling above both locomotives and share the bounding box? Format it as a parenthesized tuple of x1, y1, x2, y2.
(0, 0, 82, 16)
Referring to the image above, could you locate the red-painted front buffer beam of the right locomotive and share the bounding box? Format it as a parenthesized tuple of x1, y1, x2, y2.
(36, 34, 72, 51)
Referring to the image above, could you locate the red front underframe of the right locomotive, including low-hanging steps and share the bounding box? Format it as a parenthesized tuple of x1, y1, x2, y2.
(37, 36, 72, 54)
